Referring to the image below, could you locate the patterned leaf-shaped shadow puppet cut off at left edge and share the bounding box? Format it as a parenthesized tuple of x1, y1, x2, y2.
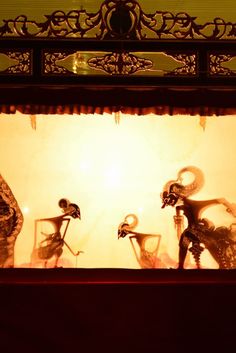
(0, 175, 23, 268)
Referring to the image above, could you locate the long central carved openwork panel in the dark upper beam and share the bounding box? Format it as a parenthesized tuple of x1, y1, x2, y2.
(43, 51, 197, 77)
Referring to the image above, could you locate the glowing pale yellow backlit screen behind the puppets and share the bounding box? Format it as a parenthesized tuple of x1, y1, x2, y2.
(0, 113, 236, 268)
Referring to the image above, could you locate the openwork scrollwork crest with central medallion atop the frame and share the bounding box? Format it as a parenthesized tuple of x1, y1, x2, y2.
(0, 0, 236, 40)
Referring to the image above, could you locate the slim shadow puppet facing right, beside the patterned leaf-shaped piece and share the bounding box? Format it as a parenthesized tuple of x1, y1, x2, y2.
(31, 199, 82, 268)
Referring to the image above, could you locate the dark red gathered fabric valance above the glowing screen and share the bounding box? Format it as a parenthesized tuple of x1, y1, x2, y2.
(0, 87, 236, 116)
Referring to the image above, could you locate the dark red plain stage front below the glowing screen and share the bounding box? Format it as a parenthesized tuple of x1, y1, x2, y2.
(0, 269, 236, 353)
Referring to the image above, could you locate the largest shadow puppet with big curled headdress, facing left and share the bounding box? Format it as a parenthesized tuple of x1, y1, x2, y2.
(161, 166, 236, 269)
